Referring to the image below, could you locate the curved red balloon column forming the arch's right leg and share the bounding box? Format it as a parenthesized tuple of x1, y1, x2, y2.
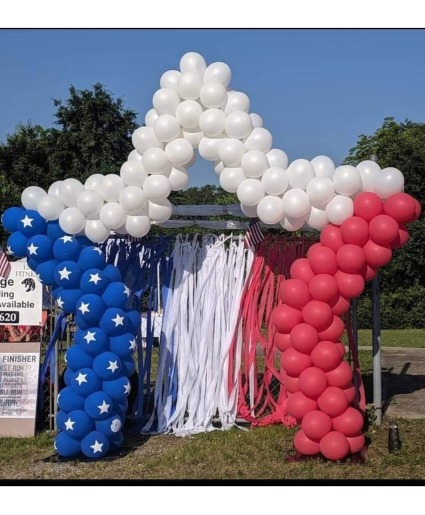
(272, 192, 420, 461)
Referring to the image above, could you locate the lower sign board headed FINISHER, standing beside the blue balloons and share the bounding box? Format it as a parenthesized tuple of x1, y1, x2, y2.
(0, 342, 40, 436)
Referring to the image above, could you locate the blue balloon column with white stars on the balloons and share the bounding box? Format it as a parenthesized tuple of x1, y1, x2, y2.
(2, 207, 141, 459)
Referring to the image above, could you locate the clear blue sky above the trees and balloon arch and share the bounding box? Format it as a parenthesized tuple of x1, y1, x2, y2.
(0, 29, 425, 185)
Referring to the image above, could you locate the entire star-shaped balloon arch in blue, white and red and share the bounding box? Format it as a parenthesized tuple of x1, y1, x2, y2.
(2, 52, 420, 460)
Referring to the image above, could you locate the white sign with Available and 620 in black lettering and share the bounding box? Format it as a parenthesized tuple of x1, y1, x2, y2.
(0, 259, 43, 326)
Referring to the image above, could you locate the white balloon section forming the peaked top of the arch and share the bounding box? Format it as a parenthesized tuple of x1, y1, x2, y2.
(22, 52, 404, 242)
